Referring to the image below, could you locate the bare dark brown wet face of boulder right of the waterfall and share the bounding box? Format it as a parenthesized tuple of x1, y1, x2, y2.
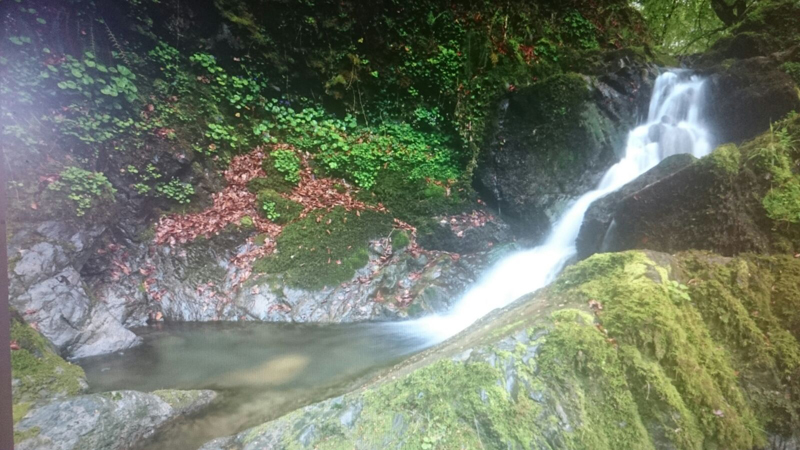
(578, 153, 770, 257)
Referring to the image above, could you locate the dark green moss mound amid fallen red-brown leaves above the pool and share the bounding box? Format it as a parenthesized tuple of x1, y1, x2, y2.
(253, 207, 391, 289)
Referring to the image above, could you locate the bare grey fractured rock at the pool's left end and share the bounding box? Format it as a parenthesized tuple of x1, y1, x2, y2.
(9, 222, 139, 357)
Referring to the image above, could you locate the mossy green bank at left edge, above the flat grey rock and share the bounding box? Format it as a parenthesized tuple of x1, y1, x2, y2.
(11, 319, 86, 402)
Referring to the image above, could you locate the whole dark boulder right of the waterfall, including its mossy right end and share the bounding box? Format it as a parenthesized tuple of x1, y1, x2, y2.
(578, 115, 800, 256)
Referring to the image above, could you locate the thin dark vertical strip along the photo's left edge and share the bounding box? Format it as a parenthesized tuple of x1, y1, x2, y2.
(0, 146, 14, 450)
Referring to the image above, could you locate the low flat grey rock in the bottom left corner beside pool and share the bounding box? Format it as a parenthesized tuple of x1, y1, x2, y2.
(15, 391, 216, 450)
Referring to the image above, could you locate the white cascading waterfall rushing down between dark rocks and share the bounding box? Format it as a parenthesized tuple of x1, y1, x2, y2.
(410, 71, 711, 342)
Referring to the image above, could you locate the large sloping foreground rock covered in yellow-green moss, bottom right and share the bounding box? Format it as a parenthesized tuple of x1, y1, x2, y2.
(203, 252, 800, 450)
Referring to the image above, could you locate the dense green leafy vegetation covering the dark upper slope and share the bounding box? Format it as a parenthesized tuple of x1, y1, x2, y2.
(0, 0, 645, 224)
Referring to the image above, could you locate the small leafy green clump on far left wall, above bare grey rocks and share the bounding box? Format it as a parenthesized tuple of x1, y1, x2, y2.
(47, 166, 117, 217)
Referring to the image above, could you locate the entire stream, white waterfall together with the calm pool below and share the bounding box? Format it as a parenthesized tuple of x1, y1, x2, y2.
(79, 71, 712, 450)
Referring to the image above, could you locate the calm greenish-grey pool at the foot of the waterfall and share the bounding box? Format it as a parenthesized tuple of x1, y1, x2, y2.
(77, 323, 425, 450)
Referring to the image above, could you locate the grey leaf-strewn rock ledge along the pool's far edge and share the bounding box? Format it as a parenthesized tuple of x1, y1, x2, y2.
(98, 236, 485, 324)
